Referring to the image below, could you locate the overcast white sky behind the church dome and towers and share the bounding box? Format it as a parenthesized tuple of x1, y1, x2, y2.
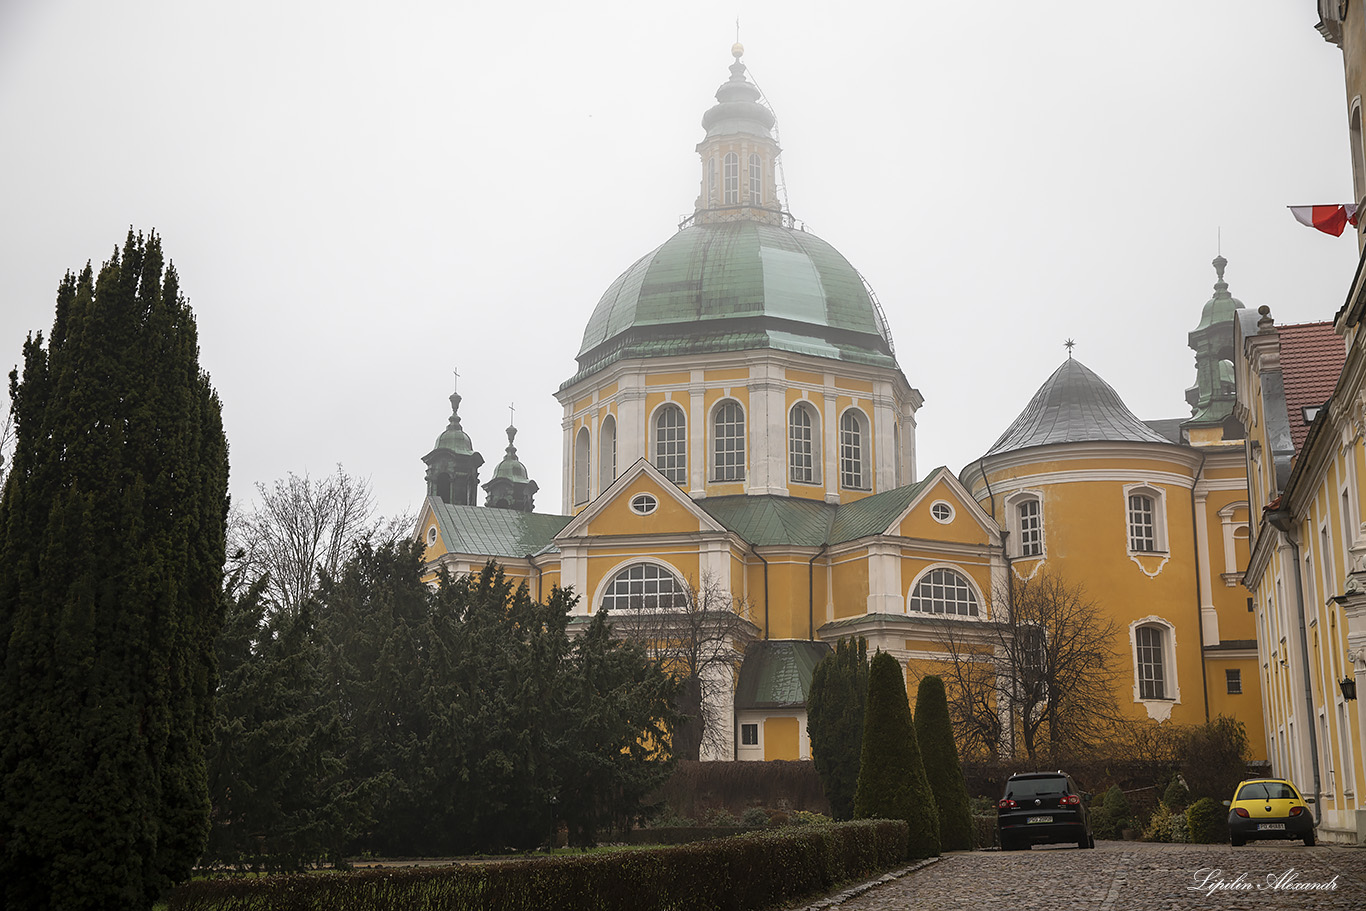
(0, 0, 1356, 524)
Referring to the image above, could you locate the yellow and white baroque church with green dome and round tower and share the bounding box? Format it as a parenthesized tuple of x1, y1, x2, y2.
(417, 46, 1262, 759)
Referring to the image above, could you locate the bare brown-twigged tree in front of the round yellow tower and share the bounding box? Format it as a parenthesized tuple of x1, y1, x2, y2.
(938, 570, 1120, 759)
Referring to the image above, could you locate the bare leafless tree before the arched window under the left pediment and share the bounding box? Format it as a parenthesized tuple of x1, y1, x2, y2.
(611, 576, 758, 759)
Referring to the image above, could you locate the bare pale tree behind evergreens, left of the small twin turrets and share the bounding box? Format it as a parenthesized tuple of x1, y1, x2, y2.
(228, 466, 413, 611)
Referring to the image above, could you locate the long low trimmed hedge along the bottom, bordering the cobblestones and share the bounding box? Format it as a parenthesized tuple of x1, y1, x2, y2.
(167, 819, 907, 911)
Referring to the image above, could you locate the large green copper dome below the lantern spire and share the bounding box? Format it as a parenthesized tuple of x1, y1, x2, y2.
(566, 220, 896, 385)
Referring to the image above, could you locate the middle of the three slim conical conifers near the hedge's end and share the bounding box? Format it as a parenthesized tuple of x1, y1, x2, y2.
(854, 651, 940, 859)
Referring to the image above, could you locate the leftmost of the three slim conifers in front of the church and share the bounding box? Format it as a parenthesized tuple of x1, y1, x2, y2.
(806, 638, 867, 819)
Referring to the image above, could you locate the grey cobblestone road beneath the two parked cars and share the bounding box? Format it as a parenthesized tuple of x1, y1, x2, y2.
(814, 841, 1366, 911)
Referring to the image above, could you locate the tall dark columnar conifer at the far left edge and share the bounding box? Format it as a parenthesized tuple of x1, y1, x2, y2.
(0, 229, 228, 908)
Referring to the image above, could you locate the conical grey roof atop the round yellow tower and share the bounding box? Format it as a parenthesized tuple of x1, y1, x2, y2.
(986, 358, 1171, 456)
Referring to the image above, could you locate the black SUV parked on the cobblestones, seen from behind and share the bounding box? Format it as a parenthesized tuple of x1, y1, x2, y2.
(996, 772, 1096, 851)
